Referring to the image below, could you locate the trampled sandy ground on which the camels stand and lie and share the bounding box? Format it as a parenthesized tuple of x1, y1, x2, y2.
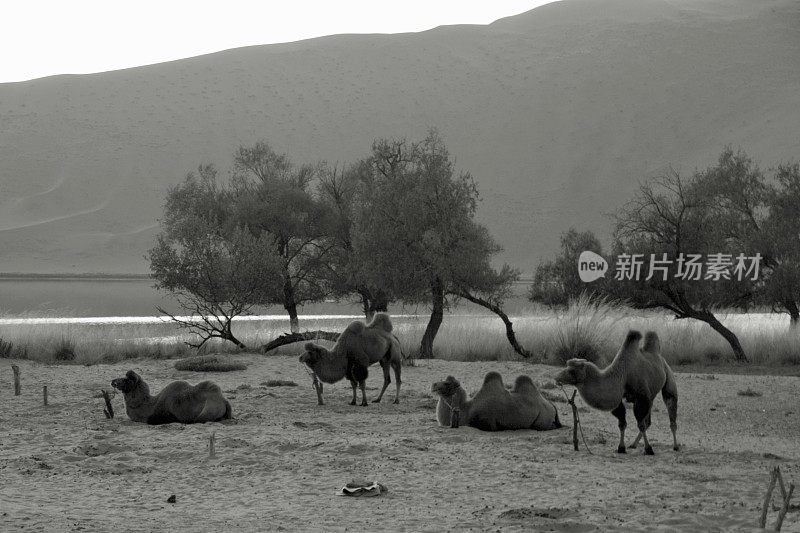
(0, 355, 800, 532)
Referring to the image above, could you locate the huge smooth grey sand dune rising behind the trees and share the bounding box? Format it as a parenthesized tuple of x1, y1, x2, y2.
(0, 0, 800, 274)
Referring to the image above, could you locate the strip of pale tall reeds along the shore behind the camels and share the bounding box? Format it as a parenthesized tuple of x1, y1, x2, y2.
(0, 297, 800, 367)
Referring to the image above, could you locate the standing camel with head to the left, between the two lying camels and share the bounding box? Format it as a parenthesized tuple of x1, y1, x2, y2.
(300, 313, 403, 406)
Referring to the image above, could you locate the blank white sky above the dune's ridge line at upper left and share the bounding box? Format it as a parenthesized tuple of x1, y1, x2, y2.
(0, 0, 552, 82)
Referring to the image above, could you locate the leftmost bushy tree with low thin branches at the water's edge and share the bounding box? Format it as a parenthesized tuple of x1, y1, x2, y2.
(148, 167, 281, 348)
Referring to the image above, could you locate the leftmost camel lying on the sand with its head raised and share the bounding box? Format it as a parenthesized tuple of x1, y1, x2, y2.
(111, 370, 232, 424)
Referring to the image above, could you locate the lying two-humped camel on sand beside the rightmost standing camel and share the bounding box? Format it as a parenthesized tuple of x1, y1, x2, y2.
(431, 372, 561, 431)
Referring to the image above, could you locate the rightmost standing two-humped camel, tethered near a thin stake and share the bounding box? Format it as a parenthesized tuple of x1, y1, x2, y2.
(556, 330, 679, 455)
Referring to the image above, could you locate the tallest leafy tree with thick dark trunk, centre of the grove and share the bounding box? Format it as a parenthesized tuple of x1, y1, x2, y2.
(353, 130, 516, 357)
